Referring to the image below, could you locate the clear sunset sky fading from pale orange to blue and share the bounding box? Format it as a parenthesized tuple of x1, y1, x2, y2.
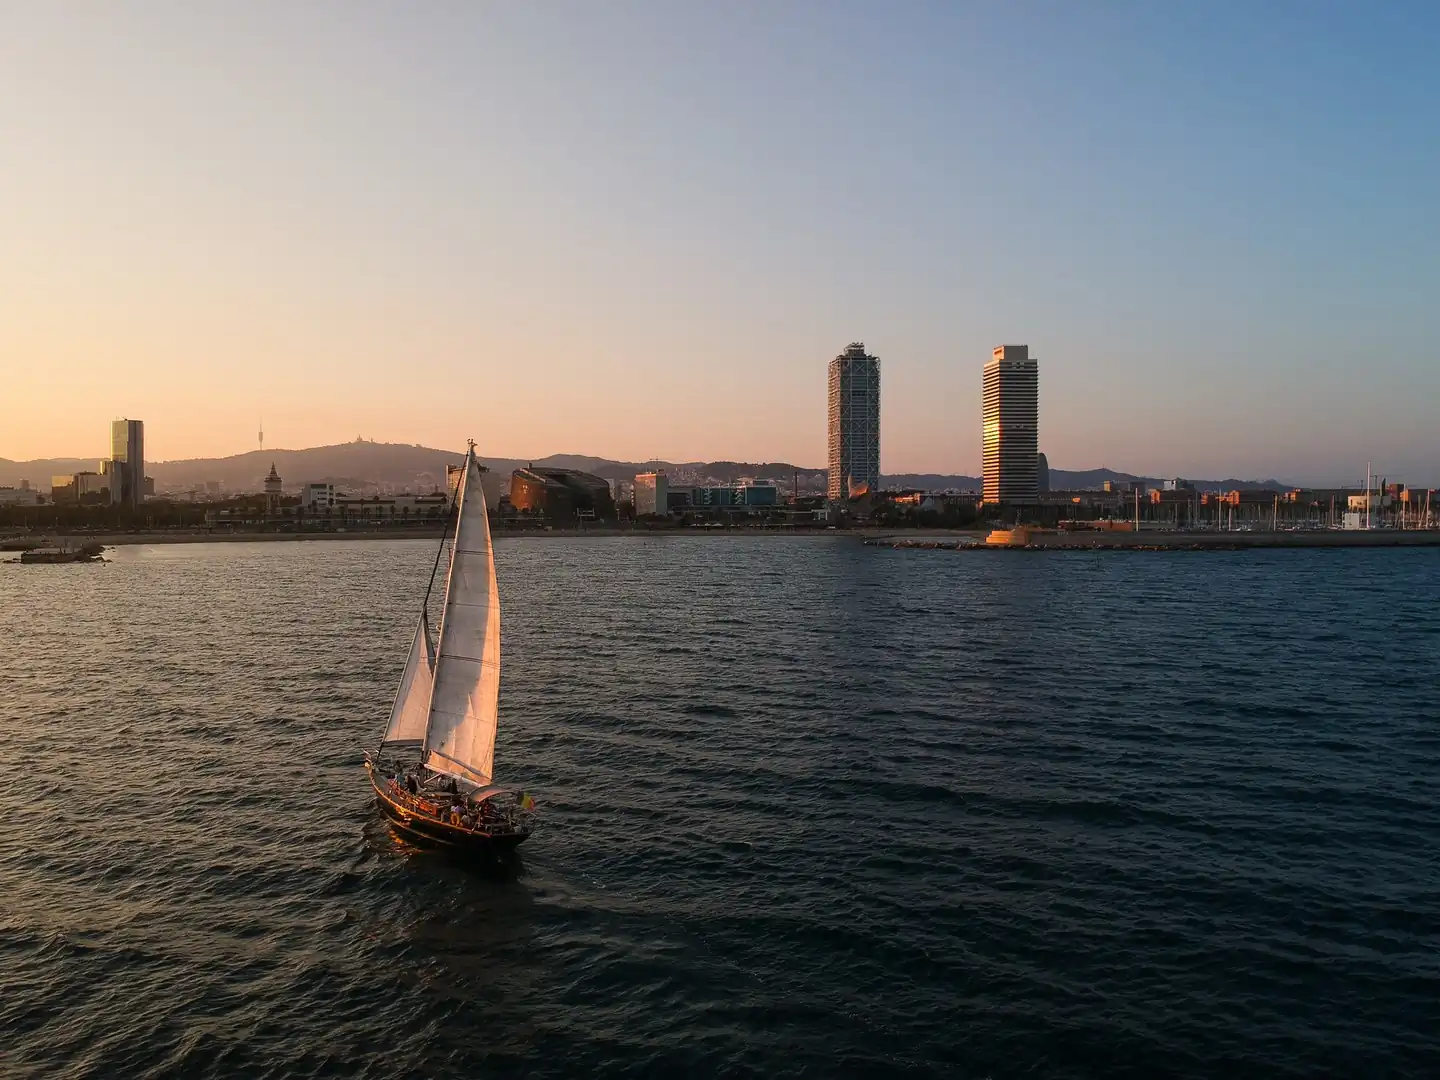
(0, 0, 1440, 484)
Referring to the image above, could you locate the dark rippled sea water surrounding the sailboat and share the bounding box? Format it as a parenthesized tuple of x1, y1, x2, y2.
(0, 537, 1440, 1077)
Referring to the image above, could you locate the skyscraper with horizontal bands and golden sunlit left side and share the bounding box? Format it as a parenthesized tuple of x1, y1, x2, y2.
(984, 346, 1048, 504)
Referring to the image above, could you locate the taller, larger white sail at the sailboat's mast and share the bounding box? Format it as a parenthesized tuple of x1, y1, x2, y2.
(425, 448, 500, 785)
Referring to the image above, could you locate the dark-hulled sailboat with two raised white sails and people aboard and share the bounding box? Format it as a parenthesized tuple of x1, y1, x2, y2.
(364, 442, 533, 850)
